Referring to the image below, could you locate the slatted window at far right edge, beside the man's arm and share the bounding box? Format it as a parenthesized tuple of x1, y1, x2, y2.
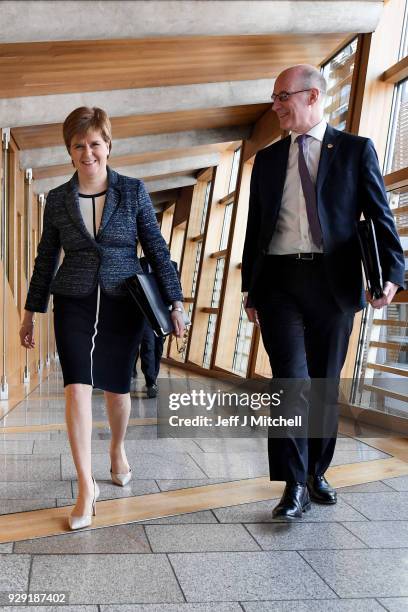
(351, 76, 408, 417)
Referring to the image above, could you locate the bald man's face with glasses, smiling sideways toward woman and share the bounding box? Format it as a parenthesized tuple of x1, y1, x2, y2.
(272, 72, 311, 132)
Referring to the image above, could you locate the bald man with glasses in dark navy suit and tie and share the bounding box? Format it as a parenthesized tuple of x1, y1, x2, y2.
(242, 65, 405, 519)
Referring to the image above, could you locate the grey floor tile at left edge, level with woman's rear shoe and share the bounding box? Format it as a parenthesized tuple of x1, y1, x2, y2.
(0, 455, 61, 482)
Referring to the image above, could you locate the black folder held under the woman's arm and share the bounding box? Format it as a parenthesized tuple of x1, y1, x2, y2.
(125, 273, 190, 337)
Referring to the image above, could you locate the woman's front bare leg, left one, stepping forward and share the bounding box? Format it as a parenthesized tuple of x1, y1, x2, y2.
(65, 383, 94, 516)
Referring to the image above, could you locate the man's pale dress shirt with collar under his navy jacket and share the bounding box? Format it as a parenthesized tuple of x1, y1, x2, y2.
(268, 119, 327, 255)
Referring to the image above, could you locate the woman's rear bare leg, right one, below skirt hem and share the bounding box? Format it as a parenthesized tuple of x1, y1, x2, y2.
(104, 391, 131, 474)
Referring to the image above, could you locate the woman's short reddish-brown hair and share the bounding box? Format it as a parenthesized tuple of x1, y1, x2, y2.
(62, 106, 112, 153)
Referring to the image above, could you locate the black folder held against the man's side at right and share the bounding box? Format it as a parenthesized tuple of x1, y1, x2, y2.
(357, 219, 383, 299)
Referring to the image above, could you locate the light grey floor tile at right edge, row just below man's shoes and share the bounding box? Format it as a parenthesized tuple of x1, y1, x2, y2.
(344, 520, 408, 548)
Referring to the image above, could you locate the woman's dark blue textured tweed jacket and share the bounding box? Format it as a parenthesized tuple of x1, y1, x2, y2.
(25, 168, 183, 312)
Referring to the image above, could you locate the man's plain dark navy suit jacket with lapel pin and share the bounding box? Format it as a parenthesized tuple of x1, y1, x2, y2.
(242, 125, 405, 312)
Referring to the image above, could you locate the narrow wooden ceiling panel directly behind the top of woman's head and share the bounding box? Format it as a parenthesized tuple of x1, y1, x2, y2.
(12, 104, 270, 150)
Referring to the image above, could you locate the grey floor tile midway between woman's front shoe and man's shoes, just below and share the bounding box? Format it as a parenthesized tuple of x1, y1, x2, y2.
(146, 524, 260, 552)
